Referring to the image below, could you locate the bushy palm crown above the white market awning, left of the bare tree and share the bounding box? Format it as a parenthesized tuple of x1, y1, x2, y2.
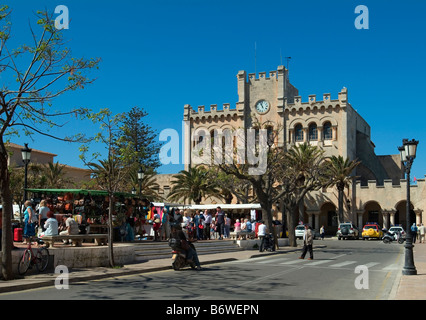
(169, 167, 221, 204)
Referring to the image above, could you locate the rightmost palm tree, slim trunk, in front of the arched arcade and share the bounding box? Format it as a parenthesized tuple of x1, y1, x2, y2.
(328, 156, 361, 222)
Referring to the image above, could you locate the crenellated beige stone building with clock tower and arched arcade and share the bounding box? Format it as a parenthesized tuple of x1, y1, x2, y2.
(160, 66, 426, 232)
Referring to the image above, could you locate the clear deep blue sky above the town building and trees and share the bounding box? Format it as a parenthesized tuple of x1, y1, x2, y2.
(3, 0, 426, 179)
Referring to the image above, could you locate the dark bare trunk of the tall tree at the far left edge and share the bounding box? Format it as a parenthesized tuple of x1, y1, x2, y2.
(0, 142, 13, 280)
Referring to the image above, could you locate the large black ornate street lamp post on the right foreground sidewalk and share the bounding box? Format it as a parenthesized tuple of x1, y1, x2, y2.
(398, 139, 419, 275)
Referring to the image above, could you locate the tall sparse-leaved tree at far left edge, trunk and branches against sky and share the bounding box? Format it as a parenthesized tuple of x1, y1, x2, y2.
(0, 6, 99, 280)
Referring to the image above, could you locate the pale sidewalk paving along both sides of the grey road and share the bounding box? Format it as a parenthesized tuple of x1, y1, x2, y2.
(0, 239, 426, 300)
